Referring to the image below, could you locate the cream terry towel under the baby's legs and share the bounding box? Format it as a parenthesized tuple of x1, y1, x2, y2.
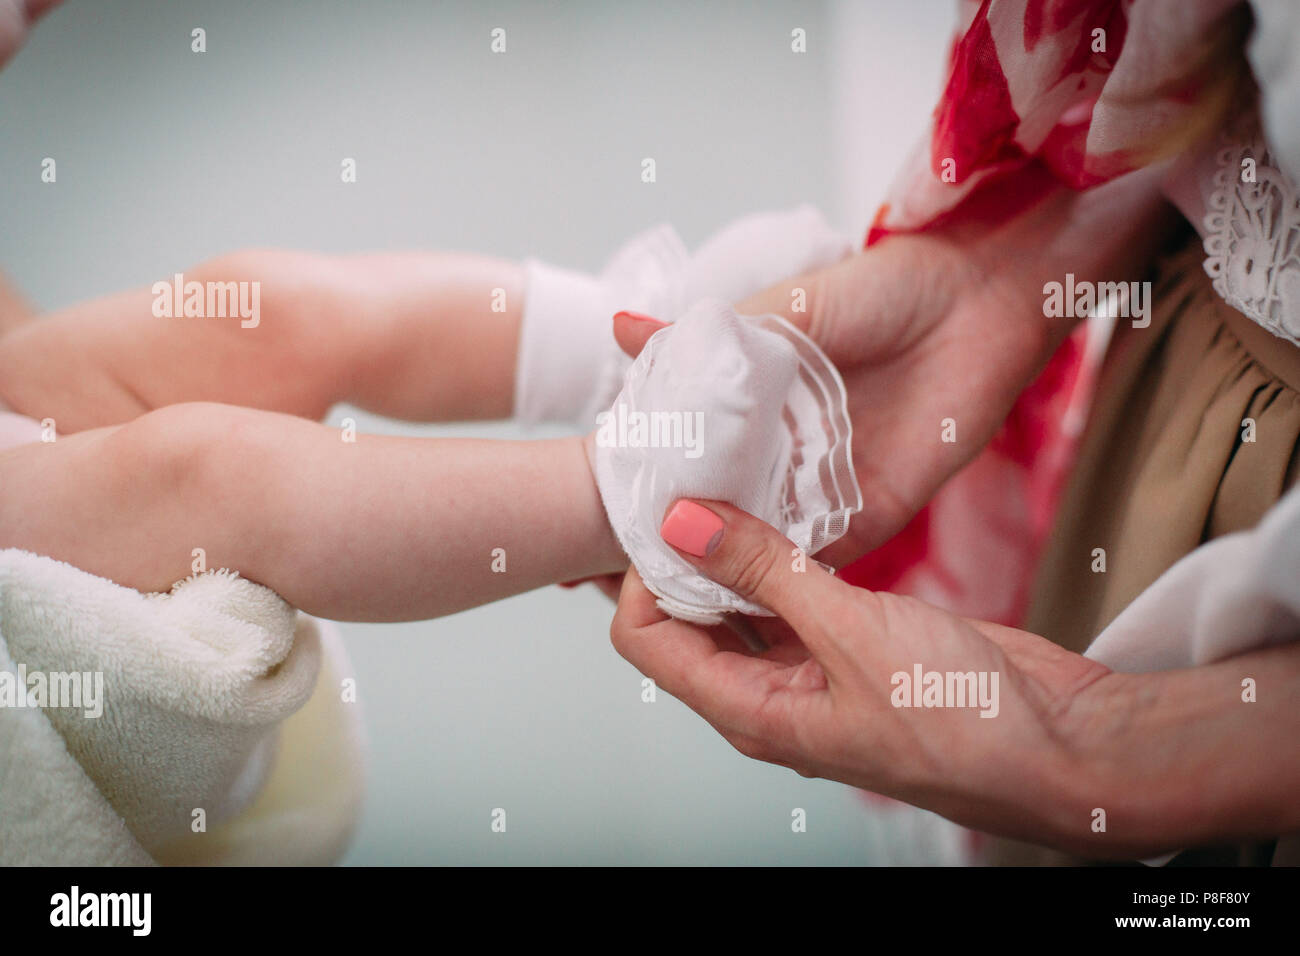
(0, 549, 363, 865)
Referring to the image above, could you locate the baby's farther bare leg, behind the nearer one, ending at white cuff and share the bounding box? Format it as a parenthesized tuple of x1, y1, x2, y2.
(0, 250, 524, 433)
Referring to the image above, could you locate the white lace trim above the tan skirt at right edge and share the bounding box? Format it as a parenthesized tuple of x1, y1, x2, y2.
(1203, 130, 1300, 345)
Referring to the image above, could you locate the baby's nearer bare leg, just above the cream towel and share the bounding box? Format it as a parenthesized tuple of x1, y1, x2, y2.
(0, 405, 627, 620)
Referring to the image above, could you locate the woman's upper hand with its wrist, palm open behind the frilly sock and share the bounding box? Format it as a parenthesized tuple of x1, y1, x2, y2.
(615, 173, 1177, 566)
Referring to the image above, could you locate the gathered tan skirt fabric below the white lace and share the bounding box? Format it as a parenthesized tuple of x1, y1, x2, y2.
(989, 237, 1300, 865)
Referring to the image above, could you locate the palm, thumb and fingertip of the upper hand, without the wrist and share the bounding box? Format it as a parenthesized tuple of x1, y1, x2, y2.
(615, 237, 1057, 564)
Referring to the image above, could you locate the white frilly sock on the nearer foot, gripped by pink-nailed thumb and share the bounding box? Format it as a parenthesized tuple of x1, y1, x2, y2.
(593, 299, 862, 624)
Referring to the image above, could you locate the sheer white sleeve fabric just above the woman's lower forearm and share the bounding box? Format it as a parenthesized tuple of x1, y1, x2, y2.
(1084, 486, 1300, 866)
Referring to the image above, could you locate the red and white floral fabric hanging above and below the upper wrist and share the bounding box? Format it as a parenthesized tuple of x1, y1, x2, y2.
(841, 0, 1249, 624)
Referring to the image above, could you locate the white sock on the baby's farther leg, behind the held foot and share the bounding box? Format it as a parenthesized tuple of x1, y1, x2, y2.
(515, 206, 853, 429)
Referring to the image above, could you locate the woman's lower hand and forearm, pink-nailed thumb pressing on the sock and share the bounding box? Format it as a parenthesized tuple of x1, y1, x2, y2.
(611, 501, 1300, 858)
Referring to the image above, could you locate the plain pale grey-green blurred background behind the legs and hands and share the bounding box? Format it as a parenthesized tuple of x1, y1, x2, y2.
(0, 0, 963, 865)
